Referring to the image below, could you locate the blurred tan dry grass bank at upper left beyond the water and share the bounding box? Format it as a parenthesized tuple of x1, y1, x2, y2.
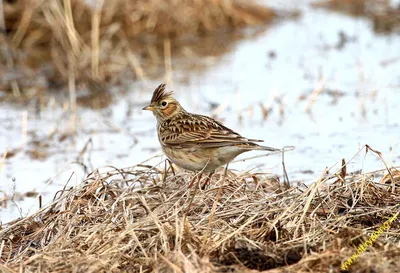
(0, 0, 276, 96)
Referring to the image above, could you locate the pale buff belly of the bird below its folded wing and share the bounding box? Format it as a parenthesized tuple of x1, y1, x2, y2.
(163, 146, 246, 173)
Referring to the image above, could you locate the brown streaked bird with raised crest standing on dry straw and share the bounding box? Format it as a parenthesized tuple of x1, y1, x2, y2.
(143, 84, 281, 185)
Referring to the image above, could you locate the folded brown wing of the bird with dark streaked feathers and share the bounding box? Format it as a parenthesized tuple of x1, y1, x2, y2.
(159, 114, 262, 148)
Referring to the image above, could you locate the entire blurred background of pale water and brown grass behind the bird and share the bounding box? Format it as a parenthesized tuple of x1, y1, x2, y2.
(0, 0, 400, 223)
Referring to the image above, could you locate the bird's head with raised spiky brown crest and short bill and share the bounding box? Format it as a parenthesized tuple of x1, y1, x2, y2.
(143, 84, 185, 122)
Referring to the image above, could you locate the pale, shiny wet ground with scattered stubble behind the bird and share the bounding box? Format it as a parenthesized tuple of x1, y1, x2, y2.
(0, 1, 400, 223)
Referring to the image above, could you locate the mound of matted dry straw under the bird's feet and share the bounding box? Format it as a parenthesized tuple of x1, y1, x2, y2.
(0, 144, 400, 272)
